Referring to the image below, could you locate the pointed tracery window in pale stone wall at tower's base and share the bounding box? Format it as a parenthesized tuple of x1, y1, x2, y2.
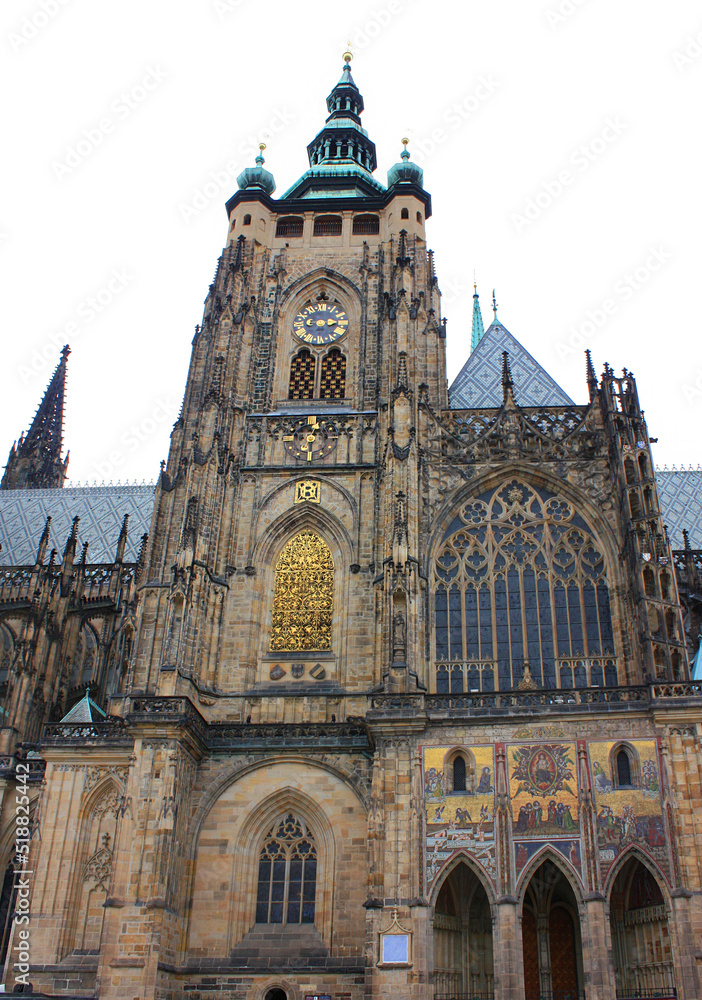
(256, 813, 317, 924)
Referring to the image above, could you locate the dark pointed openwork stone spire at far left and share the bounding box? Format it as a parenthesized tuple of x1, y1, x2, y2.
(0, 344, 71, 490)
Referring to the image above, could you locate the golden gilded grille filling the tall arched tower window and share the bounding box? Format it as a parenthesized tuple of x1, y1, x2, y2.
(270, 531, 334, 652)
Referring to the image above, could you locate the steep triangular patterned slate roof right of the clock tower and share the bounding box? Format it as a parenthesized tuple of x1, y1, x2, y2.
(449, 320, 573, 410)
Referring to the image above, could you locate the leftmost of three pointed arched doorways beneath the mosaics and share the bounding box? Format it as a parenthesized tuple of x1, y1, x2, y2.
(434, 862, 494, 998)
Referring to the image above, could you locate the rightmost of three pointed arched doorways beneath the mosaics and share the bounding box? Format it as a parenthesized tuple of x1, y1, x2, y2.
(610, 857, 675, 998)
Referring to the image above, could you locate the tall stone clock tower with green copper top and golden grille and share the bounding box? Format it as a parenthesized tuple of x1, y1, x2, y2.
(134, 53, 447, 708)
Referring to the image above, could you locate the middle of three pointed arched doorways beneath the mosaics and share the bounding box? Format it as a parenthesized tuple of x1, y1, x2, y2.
(522, 859, 583, 1000)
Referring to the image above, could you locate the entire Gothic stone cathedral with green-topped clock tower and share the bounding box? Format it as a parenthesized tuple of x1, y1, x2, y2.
(0, 53, 702, 1000)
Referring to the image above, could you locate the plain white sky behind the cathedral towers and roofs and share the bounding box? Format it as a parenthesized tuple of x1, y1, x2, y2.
(0, 0, 702, 483)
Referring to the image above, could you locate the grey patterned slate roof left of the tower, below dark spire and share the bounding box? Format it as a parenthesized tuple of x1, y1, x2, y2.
(0, 483, 156, 566)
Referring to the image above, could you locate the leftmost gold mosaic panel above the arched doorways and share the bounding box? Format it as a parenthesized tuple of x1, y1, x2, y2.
(423, 746, 496, 890)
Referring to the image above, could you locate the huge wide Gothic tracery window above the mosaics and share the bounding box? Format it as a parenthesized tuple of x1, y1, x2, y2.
(434, 480, 617, 693)
